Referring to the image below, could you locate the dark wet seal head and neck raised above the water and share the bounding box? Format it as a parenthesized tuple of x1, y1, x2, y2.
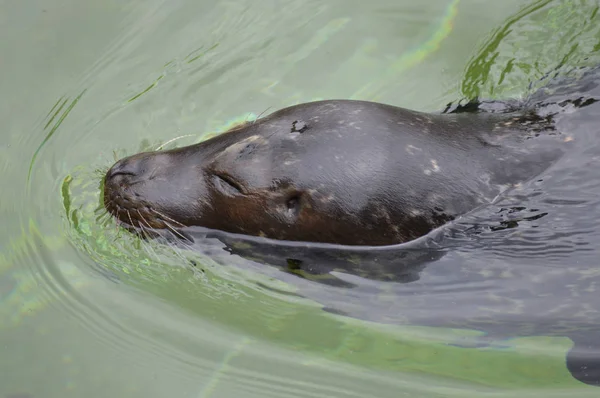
(104, 100, 569, 246)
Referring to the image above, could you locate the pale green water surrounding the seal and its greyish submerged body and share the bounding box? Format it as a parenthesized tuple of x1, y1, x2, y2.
(0, 0, 600, 398)
